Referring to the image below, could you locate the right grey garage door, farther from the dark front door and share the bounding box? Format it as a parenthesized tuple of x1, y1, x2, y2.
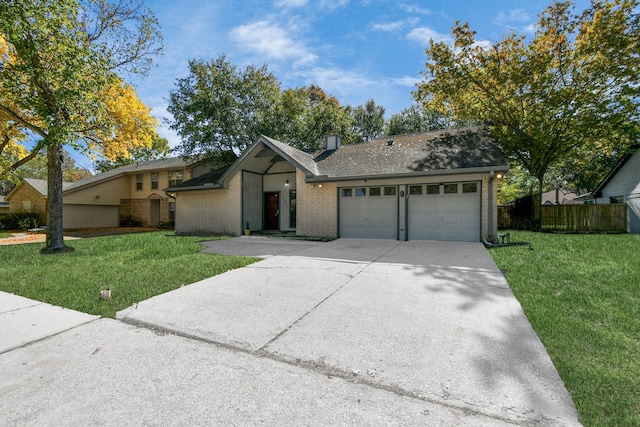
(407, 182, 481, 242)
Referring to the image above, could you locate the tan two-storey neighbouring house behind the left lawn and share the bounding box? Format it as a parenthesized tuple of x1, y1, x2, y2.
(62, 157, 191, 228)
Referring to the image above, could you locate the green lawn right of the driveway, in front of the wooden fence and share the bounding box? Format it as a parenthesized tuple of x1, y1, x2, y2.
(490, 231, 640, 426)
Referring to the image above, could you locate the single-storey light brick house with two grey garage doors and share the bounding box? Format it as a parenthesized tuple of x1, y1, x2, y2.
(166, 127, 509, 241)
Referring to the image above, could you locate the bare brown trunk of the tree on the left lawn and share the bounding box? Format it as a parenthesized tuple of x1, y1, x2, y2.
(40, 143, 73, 254)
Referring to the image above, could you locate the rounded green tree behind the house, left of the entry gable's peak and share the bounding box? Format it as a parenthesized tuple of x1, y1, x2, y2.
(168, 55, 280, 157)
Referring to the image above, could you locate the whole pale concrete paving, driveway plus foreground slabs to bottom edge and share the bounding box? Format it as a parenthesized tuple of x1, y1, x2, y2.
(0, 237, 580, 426)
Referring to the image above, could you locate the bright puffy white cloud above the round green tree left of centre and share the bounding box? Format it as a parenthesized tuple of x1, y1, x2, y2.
(231, 21, 317, 65)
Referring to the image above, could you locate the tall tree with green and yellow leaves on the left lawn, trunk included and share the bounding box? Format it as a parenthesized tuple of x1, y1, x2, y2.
(0, 0, 161, 253)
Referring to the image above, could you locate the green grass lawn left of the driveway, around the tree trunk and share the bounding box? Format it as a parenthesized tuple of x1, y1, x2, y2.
(0, 231, 258, 317)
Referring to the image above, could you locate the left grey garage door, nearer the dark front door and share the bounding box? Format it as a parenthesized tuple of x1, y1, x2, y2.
(338, 186, 398, 239)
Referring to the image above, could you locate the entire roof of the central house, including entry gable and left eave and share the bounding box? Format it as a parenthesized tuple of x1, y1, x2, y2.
(165, 126, 509, 191)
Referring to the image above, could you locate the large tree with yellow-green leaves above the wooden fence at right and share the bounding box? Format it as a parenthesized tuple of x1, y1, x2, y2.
(414, 0, 640, 226)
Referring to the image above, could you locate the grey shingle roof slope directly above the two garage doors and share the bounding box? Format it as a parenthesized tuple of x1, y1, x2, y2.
(314, 126, 509, 178)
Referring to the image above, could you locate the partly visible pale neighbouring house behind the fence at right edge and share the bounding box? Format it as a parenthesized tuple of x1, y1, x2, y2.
(578, 148, 640, 233)
